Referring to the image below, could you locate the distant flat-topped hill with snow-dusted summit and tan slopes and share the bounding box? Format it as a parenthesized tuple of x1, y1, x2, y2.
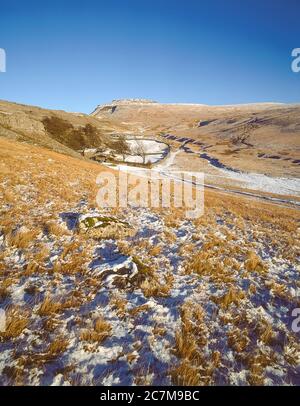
(92, 99, 300, 177)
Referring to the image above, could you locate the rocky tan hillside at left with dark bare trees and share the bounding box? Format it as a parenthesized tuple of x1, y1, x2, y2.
(0, 101, 126, 157)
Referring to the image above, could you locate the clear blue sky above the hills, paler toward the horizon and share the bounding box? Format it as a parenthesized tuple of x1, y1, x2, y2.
(0, 0, 300, 113)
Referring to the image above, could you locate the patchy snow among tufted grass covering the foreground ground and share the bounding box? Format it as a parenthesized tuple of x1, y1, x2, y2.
(0, 201, 300, 385)
